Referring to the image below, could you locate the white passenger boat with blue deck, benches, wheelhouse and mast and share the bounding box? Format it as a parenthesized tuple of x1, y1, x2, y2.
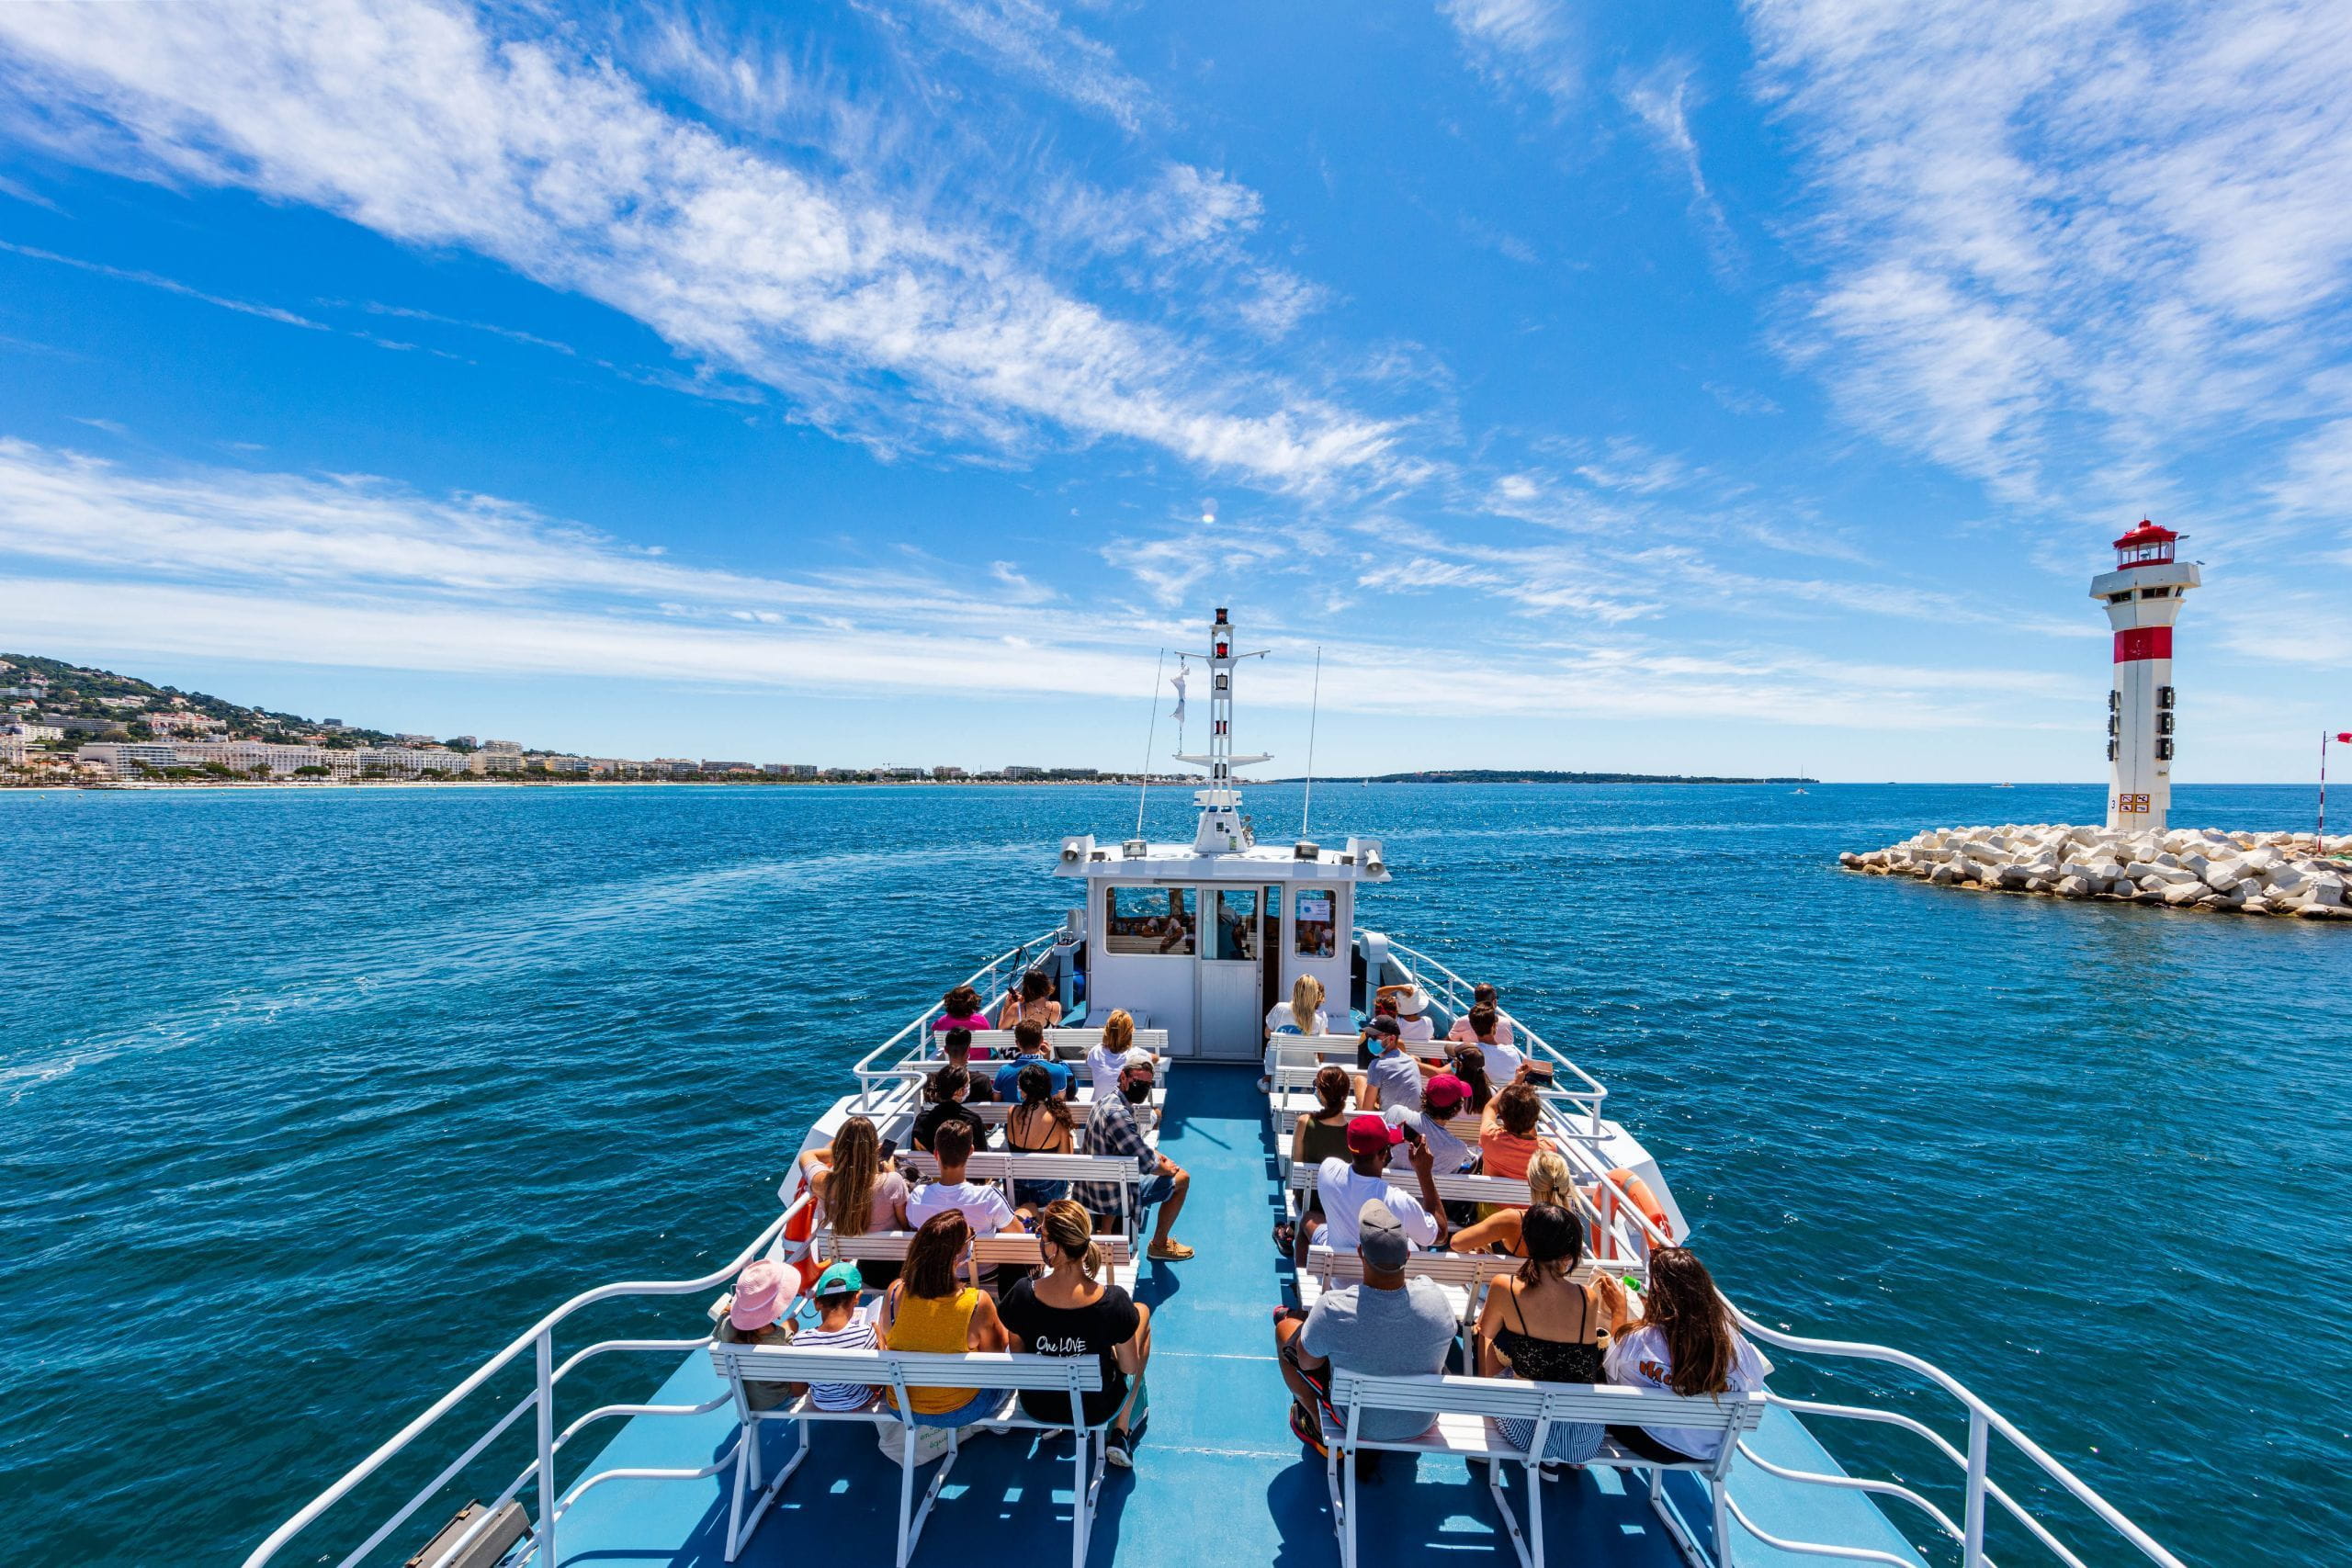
(247, 611, 2183, 1568)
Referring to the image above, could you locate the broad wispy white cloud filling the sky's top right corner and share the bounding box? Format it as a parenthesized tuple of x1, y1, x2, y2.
(1747, 0, 2352, 501)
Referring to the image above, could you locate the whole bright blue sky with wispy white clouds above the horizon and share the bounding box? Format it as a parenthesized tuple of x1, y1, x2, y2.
(0, 0, 2352, 781)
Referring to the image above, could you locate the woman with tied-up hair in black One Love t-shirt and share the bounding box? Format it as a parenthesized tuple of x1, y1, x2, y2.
(997, 1199, 1152, 1470)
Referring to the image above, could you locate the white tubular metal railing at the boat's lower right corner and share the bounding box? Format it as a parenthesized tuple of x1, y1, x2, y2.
(1726, 1303, 2185, 1568)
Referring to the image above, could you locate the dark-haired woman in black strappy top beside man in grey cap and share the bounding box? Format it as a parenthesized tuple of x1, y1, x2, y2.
(1477, 1203, 1623, 1464)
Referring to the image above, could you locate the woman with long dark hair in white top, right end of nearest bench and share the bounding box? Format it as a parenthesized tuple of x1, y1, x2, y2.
(1592, 1246, 1771, 1464)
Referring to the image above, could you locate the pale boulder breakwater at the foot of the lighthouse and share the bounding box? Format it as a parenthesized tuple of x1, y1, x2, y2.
(1837, 823, 2352, 919)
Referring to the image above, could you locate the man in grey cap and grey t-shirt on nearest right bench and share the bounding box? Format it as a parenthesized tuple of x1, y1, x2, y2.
(1275, 1199, 1456, 1453)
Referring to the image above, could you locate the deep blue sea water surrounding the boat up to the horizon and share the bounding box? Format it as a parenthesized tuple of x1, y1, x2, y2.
(0, 785, 2352, 1563)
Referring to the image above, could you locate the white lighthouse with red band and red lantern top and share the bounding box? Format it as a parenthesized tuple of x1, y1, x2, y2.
(2091, 517, 2197, 832)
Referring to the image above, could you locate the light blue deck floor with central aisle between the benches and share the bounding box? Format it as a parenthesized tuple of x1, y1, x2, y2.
(558, 1067, 1915, 1568)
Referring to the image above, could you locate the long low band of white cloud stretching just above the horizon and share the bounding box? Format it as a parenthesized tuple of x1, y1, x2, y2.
(0, 442, 2135, 727)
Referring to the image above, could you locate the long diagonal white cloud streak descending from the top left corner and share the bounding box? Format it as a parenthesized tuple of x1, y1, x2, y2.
(0, 0, 1393, 484)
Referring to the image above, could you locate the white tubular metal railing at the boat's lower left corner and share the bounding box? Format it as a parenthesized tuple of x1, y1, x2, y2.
(244, 1199, 807, 1568)
